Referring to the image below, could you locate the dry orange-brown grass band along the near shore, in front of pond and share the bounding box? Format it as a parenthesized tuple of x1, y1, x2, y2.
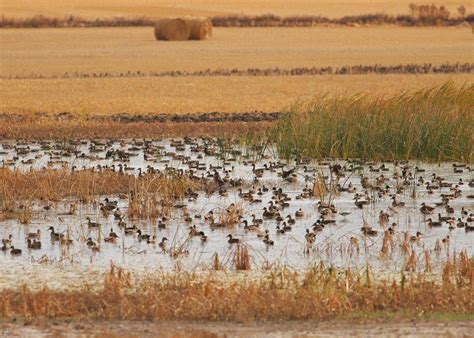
(0, 257, 474, 321)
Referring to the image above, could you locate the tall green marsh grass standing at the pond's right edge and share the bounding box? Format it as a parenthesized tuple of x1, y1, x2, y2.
(275, 83, 474, 162)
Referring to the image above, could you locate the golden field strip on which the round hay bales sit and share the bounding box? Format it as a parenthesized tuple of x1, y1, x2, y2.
(0, 27, 473, 76)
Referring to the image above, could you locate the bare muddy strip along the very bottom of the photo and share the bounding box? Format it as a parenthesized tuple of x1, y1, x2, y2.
(0, 319, 474, 337)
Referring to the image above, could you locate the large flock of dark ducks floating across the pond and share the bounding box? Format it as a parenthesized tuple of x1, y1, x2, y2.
(0, 138, 474, 262)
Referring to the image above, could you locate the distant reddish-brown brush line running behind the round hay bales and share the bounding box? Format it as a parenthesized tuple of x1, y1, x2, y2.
(0, 10, 474, 28)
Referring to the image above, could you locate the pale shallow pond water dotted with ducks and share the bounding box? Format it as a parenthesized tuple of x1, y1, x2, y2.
(0, 139, 474, 287)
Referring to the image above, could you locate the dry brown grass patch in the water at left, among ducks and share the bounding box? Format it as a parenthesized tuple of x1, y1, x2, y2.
(0, 169, 205, 217)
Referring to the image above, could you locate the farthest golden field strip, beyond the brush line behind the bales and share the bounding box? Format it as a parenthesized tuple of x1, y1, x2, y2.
(0, 0, 472, 18)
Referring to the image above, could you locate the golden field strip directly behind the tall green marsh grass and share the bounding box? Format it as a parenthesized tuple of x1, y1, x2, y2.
(0, 74, 472, 115)
